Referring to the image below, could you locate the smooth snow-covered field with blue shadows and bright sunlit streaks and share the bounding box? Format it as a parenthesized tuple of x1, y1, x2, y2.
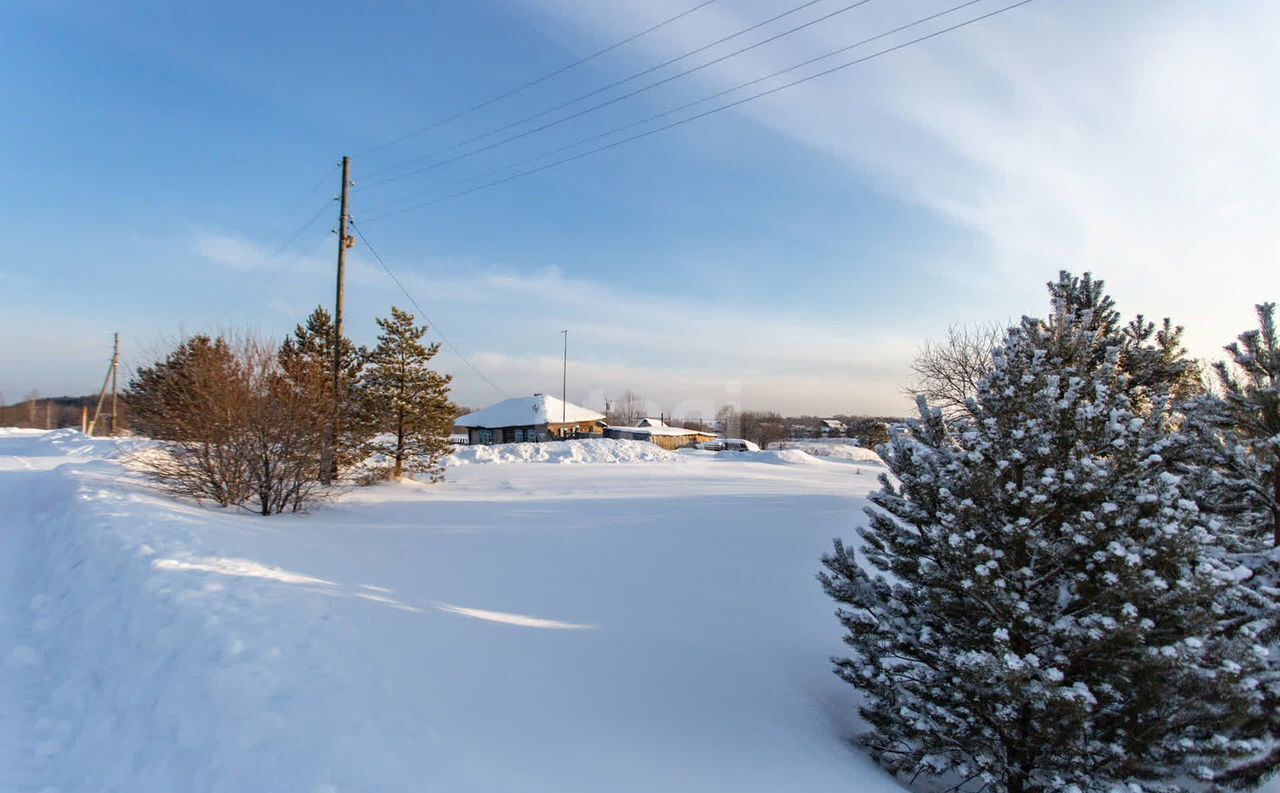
(0, 430, 901, 793)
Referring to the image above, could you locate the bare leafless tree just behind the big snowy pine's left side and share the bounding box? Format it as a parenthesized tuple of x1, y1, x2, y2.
(908, 324, 1004, 418)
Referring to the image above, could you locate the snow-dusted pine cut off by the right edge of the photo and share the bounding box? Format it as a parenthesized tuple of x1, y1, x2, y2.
(1180, 303, 1280, 787)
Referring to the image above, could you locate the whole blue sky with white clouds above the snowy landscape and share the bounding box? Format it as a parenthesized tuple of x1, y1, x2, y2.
(0, 0, 1280, 414)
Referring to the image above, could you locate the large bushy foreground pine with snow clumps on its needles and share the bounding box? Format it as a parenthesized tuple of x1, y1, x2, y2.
(819, 301, 1262, 793)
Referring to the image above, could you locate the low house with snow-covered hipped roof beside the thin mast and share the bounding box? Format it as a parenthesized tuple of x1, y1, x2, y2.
(453, 394, 604, 445)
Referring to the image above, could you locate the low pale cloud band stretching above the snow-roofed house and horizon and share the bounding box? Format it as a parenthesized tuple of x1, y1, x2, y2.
(192, 227, 916, 413)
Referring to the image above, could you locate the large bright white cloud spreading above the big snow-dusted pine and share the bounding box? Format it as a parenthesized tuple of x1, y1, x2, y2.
(512, 0, 1280, 354)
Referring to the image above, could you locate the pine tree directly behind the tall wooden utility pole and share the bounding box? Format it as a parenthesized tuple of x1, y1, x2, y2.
(276, 306, 370, 478)
